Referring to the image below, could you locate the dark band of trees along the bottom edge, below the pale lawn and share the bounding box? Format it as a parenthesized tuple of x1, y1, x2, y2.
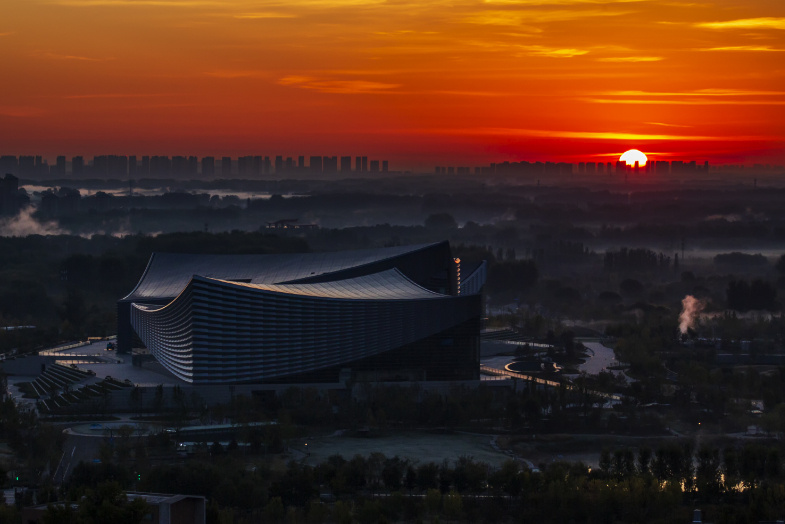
(38, 440, 785, 523)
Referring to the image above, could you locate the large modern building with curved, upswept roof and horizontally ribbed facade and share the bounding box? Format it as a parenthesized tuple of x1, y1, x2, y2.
(118, 242, 485, 384)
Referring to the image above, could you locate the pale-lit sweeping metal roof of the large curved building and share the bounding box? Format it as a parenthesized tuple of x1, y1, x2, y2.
(122, 243, 442, 302)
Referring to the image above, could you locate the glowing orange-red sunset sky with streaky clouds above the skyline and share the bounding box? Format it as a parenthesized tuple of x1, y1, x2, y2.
(0, 0, 785, 169)
